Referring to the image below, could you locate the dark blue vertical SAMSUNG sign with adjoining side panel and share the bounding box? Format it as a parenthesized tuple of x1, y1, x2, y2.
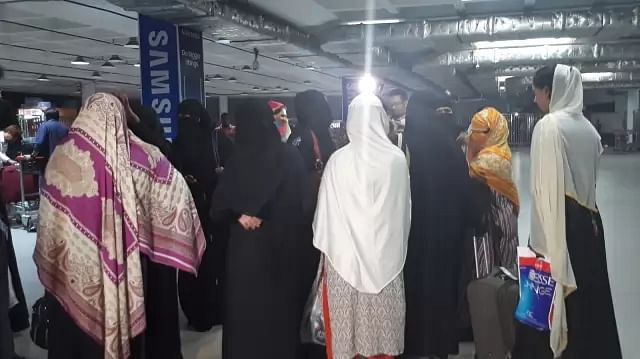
(138, 15, 205, 139)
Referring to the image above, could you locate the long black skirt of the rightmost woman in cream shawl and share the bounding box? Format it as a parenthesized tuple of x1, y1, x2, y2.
(513, 197, 622, 359)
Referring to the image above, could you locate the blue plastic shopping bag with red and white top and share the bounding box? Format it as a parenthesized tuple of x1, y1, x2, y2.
(515, 247, 556, 331)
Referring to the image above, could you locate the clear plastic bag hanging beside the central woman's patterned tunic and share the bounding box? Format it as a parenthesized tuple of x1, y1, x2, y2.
(300, 257, 325, 345)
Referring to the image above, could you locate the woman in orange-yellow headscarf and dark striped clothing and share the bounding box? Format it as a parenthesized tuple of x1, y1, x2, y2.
(467, 107, 520, 277)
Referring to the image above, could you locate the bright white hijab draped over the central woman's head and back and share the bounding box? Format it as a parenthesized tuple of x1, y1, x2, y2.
(313, 94, 411, 294)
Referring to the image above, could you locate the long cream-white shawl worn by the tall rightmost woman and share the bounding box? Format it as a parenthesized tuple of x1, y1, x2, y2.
(531, 65, 602, 357)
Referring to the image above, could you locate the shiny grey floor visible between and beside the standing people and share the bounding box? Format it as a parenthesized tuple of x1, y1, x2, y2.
(8, 151, 640, 359)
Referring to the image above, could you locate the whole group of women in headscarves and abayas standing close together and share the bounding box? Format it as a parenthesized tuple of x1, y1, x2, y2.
(0, 65, 621, 359)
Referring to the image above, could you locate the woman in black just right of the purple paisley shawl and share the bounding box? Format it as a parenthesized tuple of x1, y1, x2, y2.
(173, 100, 225, 332)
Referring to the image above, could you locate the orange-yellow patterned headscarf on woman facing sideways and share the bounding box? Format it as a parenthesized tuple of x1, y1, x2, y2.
(467, 107, 520, 212)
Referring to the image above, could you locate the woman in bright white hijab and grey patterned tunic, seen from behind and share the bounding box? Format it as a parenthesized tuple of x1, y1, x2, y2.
(314, 94, 411, 359)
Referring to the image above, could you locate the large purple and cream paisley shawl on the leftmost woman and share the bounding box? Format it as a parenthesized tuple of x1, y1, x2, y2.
(34, 94, 205, 359)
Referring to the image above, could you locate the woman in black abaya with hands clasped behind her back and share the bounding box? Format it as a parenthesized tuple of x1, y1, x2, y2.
(211, 101, 314, 359)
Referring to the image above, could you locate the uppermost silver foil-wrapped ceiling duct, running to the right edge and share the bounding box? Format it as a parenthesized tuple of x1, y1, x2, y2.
(322, 6, 640, 54)
